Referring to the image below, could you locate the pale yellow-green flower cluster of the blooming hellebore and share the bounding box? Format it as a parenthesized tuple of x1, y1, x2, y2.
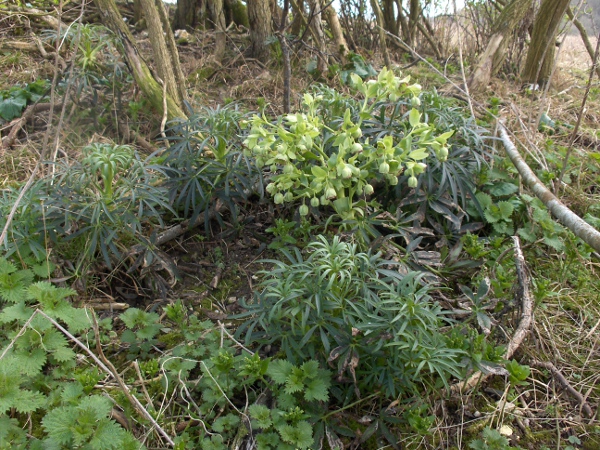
(244, 68, 453, 221)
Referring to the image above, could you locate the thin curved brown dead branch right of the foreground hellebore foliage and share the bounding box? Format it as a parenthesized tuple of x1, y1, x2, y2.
(449, 236, 533, 395)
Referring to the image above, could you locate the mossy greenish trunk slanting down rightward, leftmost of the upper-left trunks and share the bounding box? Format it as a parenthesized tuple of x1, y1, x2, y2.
(94, 0, 187, 119)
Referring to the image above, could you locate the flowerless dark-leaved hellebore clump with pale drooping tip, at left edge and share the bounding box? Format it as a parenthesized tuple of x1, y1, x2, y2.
(0, 144, 171, 267)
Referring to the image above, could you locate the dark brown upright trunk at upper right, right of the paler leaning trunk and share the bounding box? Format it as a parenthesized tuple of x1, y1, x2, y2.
(521, 0, 570, 86)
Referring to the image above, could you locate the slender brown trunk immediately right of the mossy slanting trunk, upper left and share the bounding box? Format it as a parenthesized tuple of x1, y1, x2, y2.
(140, 0, 185, 108)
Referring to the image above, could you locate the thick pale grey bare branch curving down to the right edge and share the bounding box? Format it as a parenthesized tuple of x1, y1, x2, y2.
(498, 123, 600, 252)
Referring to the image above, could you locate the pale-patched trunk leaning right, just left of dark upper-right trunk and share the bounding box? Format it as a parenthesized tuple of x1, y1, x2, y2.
(467, 0, 533, 92)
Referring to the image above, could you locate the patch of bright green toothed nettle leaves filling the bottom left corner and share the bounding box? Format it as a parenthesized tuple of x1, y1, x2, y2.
(0, 258, 140, 450)
